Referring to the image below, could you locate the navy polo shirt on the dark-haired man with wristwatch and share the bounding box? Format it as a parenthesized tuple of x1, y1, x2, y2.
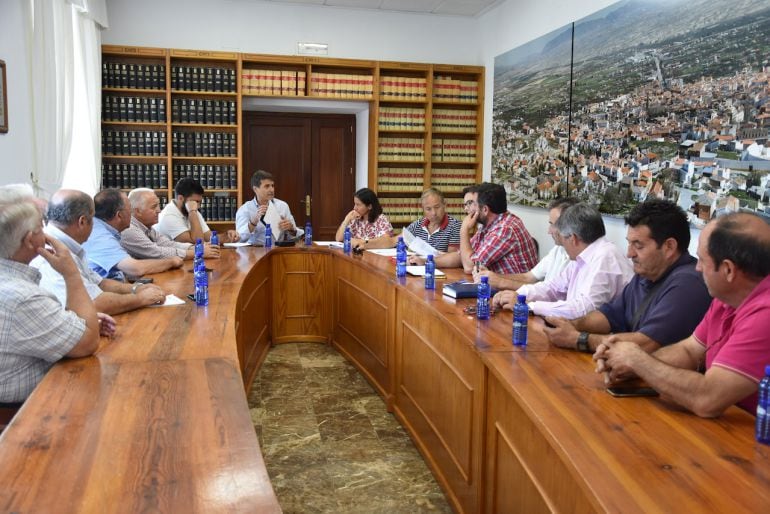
(599, 253, 711, 346)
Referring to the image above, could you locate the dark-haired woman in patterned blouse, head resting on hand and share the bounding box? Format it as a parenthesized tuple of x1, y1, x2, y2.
(336, 187, 393, 249)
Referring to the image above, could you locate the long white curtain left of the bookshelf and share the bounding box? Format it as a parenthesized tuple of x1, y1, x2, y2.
(29, 0, 107, 197)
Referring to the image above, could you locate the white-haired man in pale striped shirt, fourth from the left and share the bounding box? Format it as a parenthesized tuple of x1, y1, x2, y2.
(120, 188, 219, 260)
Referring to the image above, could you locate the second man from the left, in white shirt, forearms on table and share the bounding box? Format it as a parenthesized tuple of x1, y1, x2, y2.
(31, 189, 165, 314)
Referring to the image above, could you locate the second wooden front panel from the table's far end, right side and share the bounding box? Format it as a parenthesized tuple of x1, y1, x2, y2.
(332, 259, 395, 398)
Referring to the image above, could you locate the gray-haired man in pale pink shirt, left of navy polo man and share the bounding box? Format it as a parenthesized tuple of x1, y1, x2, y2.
(493, 203, 633, 319)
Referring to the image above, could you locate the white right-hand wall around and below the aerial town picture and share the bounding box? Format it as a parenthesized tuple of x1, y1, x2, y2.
(479, 0, 700, 255)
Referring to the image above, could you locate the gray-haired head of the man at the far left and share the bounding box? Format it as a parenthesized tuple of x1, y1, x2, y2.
(0, 186, 41, 259)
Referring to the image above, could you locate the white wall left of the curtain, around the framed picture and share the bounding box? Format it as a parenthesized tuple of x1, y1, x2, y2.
(0, 0, 33, 184)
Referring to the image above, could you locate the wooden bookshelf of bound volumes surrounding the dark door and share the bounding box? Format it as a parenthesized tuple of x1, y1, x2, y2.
(102, 45, 484, 225)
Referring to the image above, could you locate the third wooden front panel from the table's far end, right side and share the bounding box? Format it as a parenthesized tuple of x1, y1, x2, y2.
(395, 291, 486, 512)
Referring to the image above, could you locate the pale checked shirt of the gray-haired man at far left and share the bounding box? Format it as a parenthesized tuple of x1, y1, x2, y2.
(0, 259, 86, 403)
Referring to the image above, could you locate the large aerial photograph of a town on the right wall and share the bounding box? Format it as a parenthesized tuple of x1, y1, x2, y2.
(492, 0, 770, 226)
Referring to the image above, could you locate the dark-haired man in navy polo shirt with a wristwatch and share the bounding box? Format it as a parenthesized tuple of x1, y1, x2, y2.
(545, 199, 711, 353)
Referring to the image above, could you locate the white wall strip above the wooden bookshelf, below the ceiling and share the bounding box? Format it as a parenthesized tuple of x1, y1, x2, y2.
(102, 0, 481, 65)
